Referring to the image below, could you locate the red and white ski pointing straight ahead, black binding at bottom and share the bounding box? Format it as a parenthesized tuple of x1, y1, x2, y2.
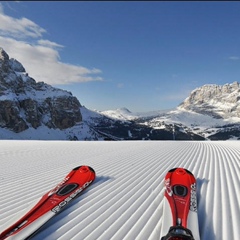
(161, 168, 200, 240)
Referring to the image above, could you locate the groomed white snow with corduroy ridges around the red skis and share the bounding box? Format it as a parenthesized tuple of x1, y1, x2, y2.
(0, 141, 240, 240)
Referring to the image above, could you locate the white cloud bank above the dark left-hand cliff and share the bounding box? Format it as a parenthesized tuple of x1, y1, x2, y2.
(0, 4, 103, 84)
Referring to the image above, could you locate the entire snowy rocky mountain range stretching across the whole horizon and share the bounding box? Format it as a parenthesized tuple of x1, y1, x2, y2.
(0, 48, 240, 140)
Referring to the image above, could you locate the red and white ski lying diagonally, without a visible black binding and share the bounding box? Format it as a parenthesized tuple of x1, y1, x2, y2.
(0, 166, 95, 240)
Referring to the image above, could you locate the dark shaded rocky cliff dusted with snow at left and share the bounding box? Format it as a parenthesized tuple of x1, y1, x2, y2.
(0, 48, 82, 132)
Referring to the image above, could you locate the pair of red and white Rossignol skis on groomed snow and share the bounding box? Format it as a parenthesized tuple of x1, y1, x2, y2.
(0, 166, 200, 240)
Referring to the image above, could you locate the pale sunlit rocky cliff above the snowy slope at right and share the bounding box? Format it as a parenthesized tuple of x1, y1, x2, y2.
(179, 82, 240, 118)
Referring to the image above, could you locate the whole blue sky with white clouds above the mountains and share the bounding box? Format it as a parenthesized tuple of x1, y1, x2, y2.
(0, 1, 240, 112)
